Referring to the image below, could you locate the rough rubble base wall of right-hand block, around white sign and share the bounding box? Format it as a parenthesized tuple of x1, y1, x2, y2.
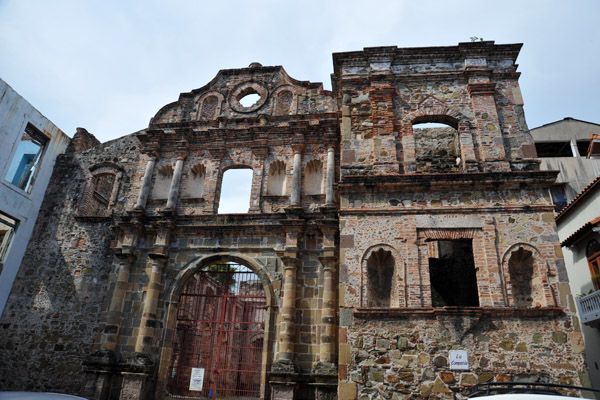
(340, 312, 585, 400)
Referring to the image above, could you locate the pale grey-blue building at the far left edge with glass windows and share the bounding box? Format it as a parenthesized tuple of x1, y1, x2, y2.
(0, 79, 69, 315)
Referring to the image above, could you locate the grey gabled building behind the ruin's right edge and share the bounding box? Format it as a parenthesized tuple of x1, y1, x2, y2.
(531, 117, 600, 212)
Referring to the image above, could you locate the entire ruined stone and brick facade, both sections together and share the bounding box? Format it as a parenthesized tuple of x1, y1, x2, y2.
(0, 42, 586, 400)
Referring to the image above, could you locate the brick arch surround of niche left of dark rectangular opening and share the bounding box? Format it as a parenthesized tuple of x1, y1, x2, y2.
(360, 243, 406, 308)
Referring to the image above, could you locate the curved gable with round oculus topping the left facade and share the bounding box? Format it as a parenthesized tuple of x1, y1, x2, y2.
(150, 63, 337, 127)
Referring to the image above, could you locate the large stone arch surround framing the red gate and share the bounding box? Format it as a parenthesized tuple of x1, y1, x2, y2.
(158, 252, 279, 394)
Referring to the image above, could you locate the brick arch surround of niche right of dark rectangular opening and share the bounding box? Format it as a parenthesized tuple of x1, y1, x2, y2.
(501, 242, 557, 307)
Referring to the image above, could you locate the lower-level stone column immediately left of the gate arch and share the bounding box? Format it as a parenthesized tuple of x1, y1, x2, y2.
(135, 253, 166, 353)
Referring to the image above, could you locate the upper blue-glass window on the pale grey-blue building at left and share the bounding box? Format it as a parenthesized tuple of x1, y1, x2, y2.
(5, 124, 48, 193)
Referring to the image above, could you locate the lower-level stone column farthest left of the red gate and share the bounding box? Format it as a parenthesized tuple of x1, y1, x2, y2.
(101, 253, 135, 351)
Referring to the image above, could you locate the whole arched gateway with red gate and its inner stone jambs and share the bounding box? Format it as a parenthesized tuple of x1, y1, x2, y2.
(158, 254, 276, 399)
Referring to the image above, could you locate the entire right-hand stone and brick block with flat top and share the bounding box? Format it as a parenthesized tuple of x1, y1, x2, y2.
(333, 42, 586, 400)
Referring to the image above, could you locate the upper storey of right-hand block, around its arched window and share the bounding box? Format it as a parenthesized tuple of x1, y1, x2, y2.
(332, 41, 538, 175)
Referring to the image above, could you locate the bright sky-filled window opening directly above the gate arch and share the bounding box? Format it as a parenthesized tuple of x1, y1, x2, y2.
(218, 168, 252, 214)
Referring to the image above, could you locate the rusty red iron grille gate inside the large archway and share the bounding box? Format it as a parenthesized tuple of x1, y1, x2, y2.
(169, 263, 266, 399)
